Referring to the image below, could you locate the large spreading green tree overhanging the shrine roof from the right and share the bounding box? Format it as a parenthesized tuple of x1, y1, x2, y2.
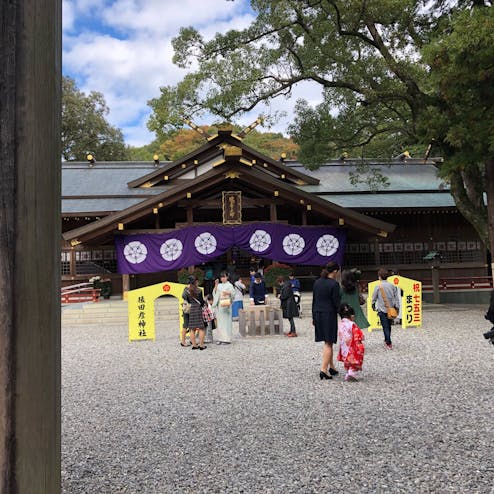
(149, 0, 494, 268)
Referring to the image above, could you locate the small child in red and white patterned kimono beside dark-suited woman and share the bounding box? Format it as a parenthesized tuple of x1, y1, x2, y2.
(338, 304, 364, 381)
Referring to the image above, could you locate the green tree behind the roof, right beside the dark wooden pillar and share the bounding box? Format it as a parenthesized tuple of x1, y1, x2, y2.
(61, 76, 128, 161)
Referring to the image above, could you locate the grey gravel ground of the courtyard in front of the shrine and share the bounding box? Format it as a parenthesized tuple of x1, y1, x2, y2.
(62, 306, 494, 494)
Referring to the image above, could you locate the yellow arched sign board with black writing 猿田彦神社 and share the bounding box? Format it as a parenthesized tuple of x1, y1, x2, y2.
(127, 281, 187, 341)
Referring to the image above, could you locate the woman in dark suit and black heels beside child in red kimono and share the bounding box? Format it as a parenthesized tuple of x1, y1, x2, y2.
(312, 261, 340, 379)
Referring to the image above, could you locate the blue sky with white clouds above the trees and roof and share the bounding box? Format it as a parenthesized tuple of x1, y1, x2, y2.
(62, 0, 320, 146)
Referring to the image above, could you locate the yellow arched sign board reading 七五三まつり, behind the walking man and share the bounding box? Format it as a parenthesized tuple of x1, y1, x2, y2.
(367, 275, 422, 331)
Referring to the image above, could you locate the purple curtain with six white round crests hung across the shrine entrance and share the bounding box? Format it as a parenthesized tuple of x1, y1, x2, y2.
(115, 223, 345, 274)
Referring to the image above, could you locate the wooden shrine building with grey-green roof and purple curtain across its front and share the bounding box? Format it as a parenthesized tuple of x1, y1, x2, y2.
(61, 125, 488, 300)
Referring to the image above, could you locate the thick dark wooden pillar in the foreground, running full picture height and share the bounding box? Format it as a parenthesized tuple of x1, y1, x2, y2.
(0, 0, 61, 494)
